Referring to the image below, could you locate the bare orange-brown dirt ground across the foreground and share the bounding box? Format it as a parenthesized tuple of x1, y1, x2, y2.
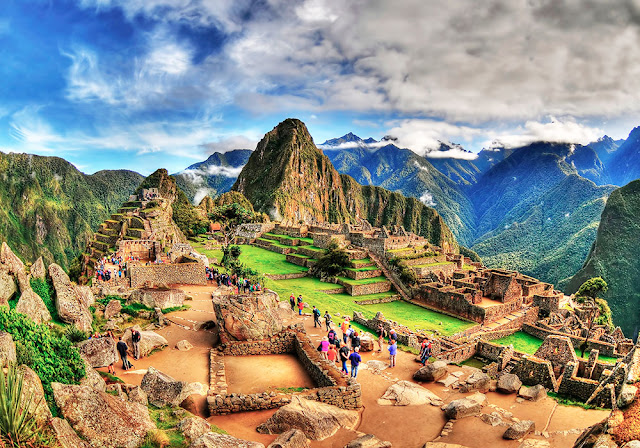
(101, 286, 609, 448)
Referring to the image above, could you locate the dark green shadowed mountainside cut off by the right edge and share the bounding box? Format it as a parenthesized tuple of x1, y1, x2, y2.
(565, 180, 640, 338)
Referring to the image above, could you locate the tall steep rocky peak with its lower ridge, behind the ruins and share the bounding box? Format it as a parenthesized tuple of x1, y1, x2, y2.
(233, 118, 458, 249)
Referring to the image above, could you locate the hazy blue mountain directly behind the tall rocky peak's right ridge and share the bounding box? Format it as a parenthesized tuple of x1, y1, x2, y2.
(320, 134, 474, 244)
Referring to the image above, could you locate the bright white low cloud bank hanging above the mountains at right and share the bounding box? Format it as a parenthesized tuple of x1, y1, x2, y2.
(489, 117, 604, 148)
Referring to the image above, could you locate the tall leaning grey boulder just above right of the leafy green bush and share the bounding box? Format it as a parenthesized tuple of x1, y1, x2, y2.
(49, 263, 93, 333)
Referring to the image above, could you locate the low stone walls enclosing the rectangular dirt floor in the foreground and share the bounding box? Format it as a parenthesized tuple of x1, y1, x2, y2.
(207, 324, 362, 415)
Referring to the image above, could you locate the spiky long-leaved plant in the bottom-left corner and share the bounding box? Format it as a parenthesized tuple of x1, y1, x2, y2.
(0, 363, 36, 446)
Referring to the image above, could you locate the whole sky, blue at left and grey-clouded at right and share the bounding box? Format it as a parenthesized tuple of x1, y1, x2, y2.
(0, 0, 640, 174)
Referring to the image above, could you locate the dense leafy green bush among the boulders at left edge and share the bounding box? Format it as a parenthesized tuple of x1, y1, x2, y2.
(0, 307, 85, 409)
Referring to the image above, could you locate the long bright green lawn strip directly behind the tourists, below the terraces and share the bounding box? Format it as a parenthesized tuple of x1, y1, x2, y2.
(267, 277, 475, 335)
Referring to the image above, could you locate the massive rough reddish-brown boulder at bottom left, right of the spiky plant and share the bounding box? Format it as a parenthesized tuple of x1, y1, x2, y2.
(51, 383, 155, 448)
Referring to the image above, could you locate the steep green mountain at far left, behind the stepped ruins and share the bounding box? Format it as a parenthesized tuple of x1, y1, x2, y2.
(0, 153, 142, 267)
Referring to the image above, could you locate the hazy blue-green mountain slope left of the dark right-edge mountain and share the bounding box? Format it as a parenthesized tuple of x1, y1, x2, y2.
(473, 174, 615, 284)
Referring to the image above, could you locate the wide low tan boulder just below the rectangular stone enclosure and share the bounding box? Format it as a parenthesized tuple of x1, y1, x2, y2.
(257, 396, 360, 440)
